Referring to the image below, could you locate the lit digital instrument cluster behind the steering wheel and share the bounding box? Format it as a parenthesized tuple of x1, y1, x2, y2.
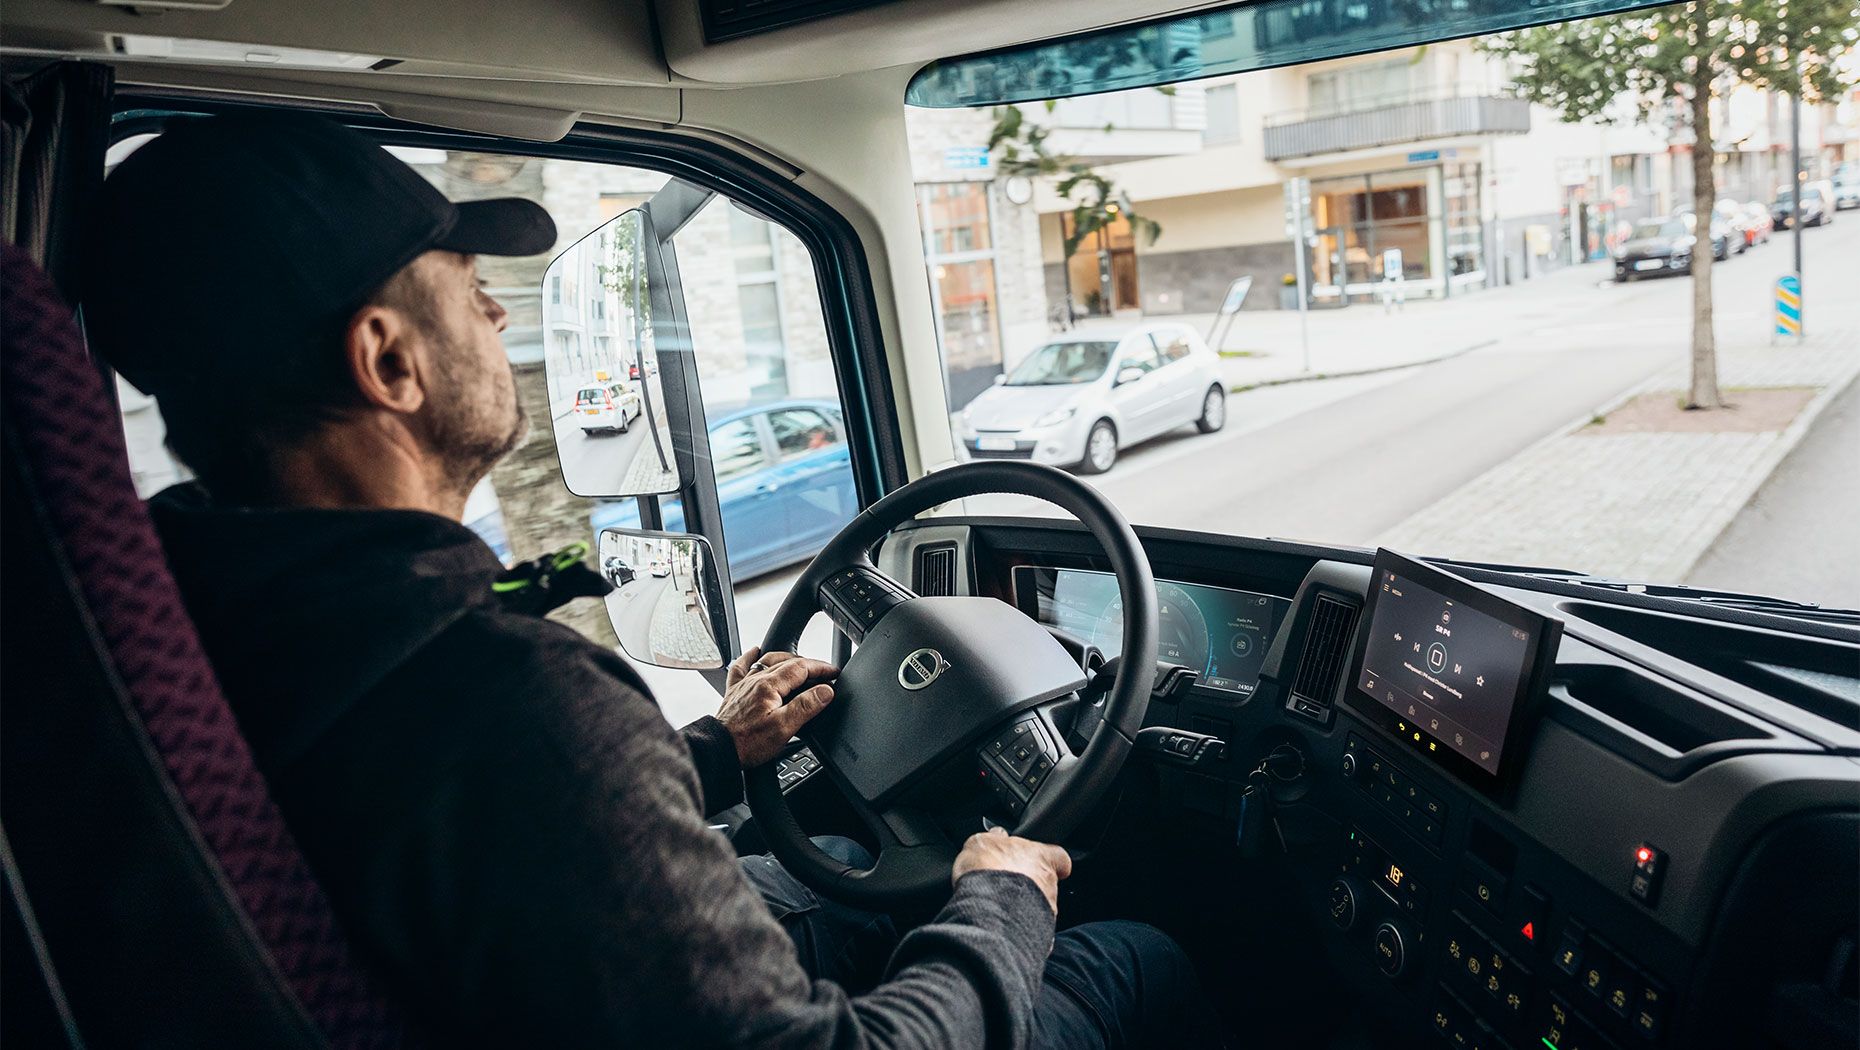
(1014, 565, 1291, 697)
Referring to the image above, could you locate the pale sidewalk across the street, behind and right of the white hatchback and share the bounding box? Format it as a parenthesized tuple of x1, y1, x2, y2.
(1079, 264, 1611, 392)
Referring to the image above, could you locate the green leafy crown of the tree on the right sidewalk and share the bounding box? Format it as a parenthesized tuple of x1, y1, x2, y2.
(1481, 0, 1860, 121)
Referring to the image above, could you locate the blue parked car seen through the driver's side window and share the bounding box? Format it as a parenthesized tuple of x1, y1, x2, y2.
(590, 400, 859, 580)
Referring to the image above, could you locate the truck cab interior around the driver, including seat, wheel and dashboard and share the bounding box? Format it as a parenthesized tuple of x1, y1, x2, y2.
(0, 0, 1860, 1050)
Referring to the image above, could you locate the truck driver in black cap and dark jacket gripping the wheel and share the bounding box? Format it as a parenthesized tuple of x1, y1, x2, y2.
(84, 115, 1211, 1048)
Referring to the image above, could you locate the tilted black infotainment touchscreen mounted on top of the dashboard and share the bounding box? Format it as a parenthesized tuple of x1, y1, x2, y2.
(1352, 550, 1562, 788)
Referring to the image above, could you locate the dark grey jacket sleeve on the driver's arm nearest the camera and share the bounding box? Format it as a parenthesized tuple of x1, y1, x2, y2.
(391, 624, 1053, 1050)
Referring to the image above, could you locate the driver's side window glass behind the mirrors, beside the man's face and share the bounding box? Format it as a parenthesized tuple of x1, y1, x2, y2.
(118, 127, 859, 725)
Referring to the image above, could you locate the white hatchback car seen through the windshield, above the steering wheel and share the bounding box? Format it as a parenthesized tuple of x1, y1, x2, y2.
(956, 323, 1228, 474)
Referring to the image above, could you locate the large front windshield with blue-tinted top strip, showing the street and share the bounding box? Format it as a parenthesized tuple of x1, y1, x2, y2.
(906, 0, 1860, 608)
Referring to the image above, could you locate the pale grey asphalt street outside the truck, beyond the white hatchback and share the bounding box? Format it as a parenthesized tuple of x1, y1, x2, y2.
(651, 221, 1860, 725)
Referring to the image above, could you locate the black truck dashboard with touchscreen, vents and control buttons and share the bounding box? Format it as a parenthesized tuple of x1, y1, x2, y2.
(880, 518, 1860, 1050)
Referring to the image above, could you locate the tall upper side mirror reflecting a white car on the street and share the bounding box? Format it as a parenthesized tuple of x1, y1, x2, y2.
(543, 208, 679, 496)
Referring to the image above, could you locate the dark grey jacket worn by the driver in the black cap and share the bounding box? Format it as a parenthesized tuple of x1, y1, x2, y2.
(154, 487, 1053, 1048)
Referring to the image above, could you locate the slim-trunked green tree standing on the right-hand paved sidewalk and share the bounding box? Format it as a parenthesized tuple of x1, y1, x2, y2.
(1482, 0, 1860, 409)
